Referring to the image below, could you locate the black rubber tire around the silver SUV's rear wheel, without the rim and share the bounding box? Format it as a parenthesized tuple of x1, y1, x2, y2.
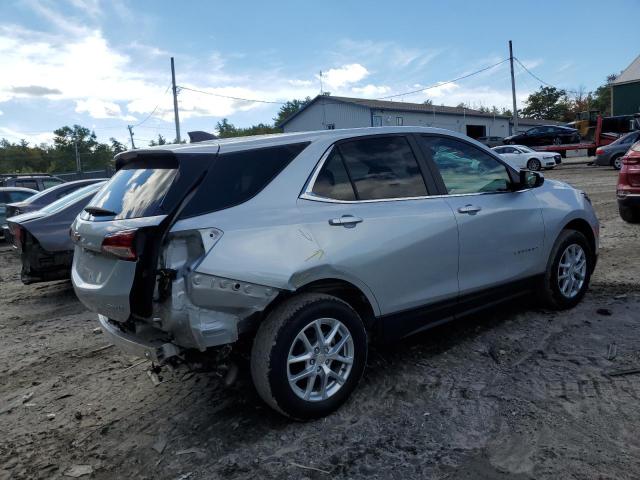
(251, 293, 367, 420)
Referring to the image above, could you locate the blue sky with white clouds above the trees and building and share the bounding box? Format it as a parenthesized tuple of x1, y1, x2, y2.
(0, 0, 640, 145)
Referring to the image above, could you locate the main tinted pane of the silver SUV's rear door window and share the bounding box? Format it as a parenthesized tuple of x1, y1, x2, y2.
(339, 137, 427, 200)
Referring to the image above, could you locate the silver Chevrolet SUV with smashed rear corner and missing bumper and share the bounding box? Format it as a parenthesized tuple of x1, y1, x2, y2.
(71, 127, 599, 419)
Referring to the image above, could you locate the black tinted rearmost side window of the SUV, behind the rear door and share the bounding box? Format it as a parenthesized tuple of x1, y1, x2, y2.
(181, 142, 309, 218)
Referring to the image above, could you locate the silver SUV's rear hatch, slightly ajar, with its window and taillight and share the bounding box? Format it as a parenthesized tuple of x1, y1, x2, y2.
(71, 150, 217, 322)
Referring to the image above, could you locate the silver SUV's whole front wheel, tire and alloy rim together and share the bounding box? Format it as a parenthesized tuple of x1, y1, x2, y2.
(539, 230, 595, 310)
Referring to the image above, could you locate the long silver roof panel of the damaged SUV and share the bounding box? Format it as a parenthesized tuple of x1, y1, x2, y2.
(116, 126, 482, 161)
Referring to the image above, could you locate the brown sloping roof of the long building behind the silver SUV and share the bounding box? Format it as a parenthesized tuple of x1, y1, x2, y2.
(278, 95, 511, 127)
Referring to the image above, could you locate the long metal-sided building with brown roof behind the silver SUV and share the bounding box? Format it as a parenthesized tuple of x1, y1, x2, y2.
(280, 95, 559, 138)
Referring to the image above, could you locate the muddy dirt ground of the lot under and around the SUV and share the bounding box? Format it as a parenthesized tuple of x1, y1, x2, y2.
(0, 164, 640, 480)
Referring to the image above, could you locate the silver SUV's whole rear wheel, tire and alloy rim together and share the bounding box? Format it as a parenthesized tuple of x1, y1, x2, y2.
(251, 293, 367, 420)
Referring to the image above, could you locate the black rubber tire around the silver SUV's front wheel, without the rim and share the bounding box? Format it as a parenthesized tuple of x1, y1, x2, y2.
(539, 229, 596, 310)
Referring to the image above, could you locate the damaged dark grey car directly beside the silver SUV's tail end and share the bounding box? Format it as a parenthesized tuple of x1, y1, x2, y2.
(7, 182, 106, 284)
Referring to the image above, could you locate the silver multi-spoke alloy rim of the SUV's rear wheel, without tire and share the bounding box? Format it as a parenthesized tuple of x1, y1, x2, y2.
(287, 318, 355, 402)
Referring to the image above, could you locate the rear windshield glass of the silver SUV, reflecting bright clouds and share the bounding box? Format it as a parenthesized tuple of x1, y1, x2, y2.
(89, 159, 178, 220)
